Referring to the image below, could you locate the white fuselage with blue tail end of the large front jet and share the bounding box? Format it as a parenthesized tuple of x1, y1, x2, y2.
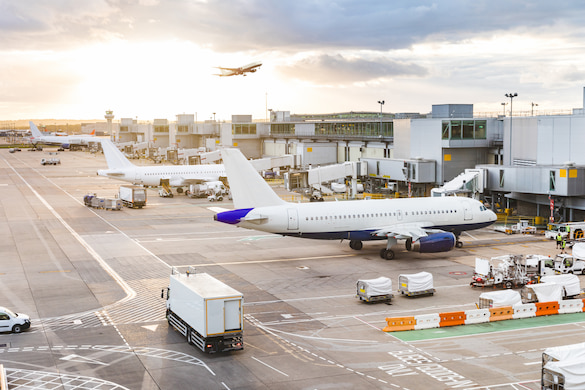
(216, 197, 495, 241)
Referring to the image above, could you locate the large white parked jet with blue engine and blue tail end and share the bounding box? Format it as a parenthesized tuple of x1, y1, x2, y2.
(214, 149, 497, 260)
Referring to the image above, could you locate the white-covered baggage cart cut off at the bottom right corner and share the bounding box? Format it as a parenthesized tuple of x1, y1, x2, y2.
(540, 343, 585, 390)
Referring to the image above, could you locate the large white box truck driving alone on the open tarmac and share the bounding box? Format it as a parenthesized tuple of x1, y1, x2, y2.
(161, 267, 244, 353)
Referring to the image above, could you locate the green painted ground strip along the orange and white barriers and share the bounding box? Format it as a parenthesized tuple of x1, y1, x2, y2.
(388, 313, 585, 341)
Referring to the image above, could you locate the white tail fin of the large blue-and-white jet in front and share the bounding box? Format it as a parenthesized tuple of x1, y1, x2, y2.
(221, 149, 286, 209)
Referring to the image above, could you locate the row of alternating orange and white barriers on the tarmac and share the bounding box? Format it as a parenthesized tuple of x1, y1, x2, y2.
(383, 299, 585, 332)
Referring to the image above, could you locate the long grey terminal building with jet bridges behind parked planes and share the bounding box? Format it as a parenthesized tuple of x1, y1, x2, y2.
(85, 88, 585, 222)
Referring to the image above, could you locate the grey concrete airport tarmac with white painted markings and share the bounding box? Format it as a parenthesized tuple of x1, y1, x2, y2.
(0, 148, 585, 390)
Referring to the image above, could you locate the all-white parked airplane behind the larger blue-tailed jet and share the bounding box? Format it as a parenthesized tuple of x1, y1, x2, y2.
(97, 139, 226, 193)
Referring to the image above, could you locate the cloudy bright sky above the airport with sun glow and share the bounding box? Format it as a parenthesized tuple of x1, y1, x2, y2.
(0, 0, 585, 121)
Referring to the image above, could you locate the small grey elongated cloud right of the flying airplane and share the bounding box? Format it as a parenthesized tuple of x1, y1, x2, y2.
(279, 54, 427, 85)
